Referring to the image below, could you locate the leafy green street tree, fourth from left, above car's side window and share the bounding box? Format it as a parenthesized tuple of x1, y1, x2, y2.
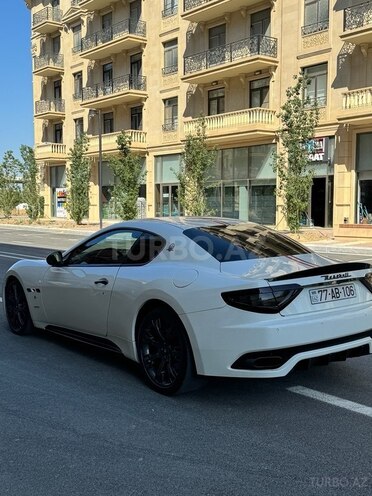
(108, 131, 144, 220)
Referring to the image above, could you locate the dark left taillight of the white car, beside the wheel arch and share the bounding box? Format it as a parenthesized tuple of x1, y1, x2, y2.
(221, 284, 302, 313)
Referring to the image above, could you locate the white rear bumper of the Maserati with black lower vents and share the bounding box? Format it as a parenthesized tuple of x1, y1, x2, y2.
(187, 304, 372, 378)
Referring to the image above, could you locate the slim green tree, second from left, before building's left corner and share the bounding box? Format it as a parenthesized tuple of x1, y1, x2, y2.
(20, 145, 44, 221)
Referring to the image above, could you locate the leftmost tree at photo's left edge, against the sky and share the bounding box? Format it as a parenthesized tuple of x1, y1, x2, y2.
(0, 150, 21, 218)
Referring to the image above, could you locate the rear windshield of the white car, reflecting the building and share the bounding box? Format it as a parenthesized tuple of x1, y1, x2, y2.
(184, 224, 312, 262)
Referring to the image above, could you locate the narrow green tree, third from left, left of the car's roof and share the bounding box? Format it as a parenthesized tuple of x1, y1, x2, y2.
(66, 134, 91, 224)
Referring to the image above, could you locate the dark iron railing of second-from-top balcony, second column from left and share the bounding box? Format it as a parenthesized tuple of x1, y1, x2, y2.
(75, 19, 146, 52)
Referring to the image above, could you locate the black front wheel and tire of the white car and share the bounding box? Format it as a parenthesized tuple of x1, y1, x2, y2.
(4, 277, 34, 335)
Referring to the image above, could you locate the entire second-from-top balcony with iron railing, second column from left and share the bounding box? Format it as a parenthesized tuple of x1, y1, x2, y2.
(74, 19, 146, 60)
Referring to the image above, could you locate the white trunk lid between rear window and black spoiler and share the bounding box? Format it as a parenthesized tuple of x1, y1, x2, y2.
(221, 253, 337, 279)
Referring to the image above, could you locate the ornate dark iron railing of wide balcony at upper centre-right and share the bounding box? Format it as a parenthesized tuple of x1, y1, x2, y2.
(184, 35, 278, 74)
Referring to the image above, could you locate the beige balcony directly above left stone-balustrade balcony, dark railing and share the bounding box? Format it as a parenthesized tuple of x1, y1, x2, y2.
(81, 74, 147, 108)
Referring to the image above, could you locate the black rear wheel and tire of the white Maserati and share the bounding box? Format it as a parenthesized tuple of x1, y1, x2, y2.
(137, 306, 199, 396)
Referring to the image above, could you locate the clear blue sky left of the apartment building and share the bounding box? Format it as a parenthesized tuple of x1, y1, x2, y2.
(0, 0, 34, 160)
